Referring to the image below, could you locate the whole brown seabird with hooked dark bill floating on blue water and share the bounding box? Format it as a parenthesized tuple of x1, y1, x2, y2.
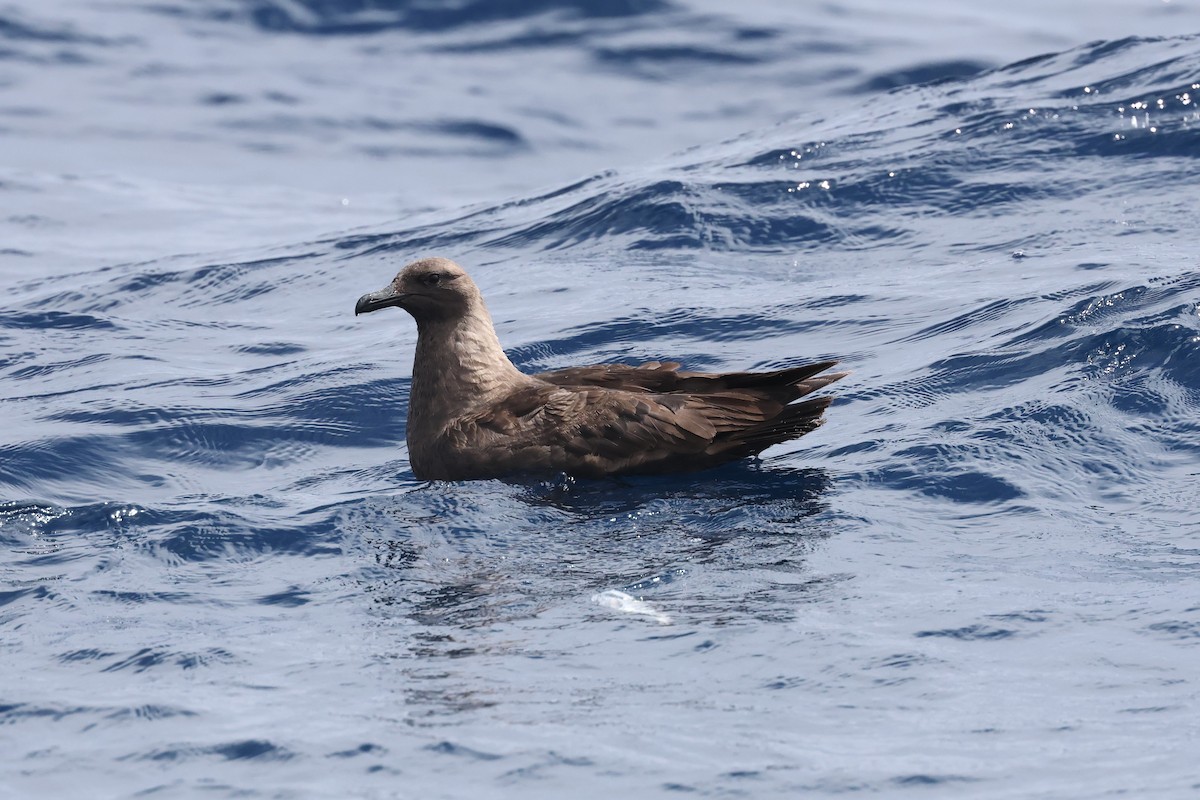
(354, 258, 848, 481)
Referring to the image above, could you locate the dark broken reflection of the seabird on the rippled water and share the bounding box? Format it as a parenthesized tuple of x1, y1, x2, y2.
(352, 462, 834, 723)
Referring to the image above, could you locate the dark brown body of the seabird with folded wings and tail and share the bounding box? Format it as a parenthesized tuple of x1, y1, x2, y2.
(414, 361, 846, 480)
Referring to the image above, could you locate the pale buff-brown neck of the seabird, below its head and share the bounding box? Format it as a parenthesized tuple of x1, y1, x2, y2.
(408, 305, 528, 432)
